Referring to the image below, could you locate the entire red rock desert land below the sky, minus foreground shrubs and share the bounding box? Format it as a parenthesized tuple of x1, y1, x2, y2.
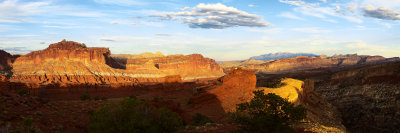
(0, 40, 400, 132)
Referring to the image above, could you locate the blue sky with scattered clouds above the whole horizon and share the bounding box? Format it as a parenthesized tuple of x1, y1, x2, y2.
(0, 0, 400, 61)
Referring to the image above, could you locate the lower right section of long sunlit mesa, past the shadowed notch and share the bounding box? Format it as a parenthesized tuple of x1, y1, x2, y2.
(120, 54, 223, 80)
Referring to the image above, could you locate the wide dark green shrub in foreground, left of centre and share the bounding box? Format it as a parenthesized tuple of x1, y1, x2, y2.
(88, 97, 183, 133)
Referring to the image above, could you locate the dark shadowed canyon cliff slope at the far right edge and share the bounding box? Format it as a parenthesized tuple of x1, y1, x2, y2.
(316, 62, 400, 132)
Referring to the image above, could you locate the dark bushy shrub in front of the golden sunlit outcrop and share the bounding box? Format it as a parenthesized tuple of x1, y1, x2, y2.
(230, 91, 306, 133)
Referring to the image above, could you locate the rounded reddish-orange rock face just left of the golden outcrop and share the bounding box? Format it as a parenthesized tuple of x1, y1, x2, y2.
(192, 68, 257, 122)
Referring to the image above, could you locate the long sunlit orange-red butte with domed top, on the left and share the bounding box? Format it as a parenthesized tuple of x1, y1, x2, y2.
(9, 40, 224, 85)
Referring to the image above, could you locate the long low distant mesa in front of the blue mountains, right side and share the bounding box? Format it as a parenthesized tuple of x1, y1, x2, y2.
(220, 54, 389, 73)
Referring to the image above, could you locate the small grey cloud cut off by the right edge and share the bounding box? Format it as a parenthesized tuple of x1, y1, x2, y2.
(362, 6, 400, 20)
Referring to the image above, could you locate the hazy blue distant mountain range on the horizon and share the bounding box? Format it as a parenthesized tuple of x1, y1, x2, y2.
(250, 52, 318, 60)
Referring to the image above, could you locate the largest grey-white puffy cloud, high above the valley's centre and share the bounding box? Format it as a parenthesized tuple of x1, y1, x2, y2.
(152, 3, 270, 29)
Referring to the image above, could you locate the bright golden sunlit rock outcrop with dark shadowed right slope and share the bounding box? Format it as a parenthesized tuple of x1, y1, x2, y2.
(257, 78, 346, 132)
